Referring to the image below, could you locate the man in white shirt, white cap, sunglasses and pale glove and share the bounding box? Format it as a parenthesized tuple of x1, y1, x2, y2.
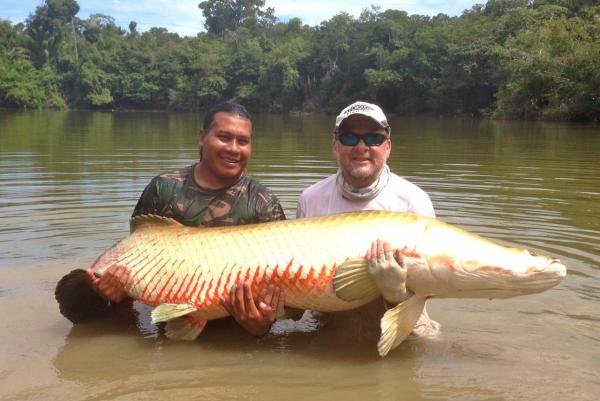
(297, 102, 439, 335)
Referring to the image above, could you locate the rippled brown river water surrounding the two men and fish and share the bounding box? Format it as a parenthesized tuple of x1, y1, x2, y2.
(0, 111, 600, 401)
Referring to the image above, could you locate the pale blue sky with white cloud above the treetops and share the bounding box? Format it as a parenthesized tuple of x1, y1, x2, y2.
(0, 0, 486, 36)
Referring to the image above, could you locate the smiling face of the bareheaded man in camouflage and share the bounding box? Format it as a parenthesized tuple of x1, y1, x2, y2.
(199, 112, 252, 188)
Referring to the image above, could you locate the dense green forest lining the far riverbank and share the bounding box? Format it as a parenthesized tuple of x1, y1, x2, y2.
(0, 0, 600, 121)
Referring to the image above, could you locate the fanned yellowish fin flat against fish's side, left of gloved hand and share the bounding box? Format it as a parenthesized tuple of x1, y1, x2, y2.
(333, 257, 379, 301)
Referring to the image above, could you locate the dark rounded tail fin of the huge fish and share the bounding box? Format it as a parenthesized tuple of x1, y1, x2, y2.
(54, 269, 110, 323)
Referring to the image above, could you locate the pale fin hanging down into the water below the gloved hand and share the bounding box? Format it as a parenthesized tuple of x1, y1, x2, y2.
(377, 295, 426, 356)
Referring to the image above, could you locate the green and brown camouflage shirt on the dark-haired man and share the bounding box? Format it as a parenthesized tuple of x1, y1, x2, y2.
(132, 166, 285, 226)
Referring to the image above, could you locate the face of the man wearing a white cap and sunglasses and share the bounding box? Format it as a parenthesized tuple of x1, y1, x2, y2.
(333, 115, 392, 188)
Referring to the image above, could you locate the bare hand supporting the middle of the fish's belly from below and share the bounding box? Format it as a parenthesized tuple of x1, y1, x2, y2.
(221, 283, 284, 337)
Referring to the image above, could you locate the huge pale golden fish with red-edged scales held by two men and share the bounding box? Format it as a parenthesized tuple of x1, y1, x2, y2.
(56, 211, 566, 356)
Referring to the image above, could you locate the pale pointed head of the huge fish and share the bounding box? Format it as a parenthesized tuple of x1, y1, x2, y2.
(407, 220, 567, 298)
